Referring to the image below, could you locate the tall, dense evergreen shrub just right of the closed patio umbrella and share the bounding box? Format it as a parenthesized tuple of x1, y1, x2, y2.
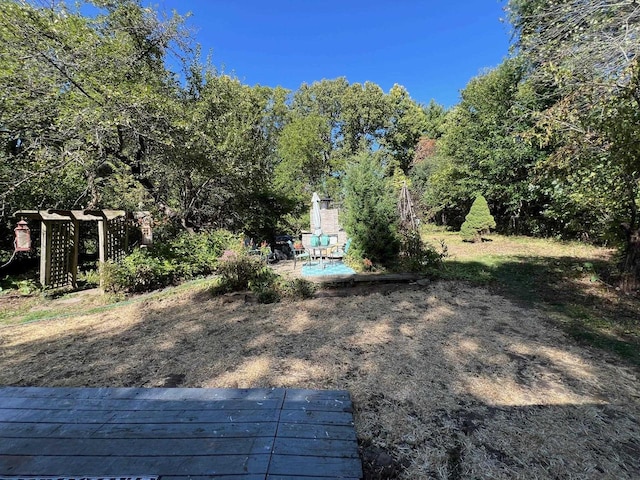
(342, 152, 400, 264)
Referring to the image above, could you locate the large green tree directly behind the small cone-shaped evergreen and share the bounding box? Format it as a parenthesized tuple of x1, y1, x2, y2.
(416, 58, 547, 232)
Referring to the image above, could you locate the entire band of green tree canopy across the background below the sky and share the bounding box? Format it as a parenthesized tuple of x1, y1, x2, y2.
(0, 0, 640, 284)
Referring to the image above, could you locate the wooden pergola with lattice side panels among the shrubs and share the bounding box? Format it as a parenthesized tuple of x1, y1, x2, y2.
(14, 210, 129, 288)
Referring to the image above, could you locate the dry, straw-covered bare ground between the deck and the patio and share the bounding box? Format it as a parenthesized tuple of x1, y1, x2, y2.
(0, 282, 640, 479)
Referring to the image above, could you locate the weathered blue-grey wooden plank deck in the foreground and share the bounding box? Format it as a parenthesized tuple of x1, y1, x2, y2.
(0, 387, 362, 480)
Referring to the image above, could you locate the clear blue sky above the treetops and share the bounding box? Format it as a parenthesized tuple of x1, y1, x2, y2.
(150, 0, 510, 107)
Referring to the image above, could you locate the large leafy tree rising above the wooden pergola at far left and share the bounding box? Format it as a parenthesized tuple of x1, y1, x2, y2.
(0, 0, 189, 219)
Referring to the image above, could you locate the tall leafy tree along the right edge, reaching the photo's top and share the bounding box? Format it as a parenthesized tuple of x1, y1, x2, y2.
(508, 0, 640, 283)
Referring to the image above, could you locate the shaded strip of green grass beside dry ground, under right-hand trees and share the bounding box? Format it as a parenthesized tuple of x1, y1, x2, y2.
(445, 256, 640, 365)
